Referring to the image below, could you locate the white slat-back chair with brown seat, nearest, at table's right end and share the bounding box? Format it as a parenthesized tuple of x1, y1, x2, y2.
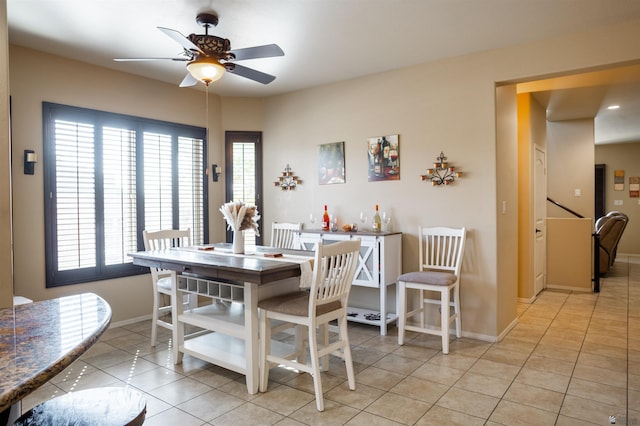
(258, 239, 360, 411)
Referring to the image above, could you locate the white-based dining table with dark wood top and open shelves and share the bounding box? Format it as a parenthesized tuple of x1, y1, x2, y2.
(129, 243, 314, 394)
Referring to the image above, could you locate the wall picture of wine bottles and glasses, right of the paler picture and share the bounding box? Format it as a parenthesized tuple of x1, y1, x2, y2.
(367, 135, 400, 182)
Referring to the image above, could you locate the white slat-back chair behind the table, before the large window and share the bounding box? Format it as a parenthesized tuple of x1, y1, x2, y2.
(142, 229, 191, 346)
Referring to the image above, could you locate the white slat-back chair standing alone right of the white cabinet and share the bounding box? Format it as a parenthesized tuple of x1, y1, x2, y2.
(398, 227, 466, 354)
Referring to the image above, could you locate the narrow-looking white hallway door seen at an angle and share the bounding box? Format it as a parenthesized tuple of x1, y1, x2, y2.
(533, 145, 547, 295)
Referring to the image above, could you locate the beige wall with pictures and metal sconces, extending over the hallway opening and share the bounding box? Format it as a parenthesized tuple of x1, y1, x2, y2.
(264, 22, 640, 336)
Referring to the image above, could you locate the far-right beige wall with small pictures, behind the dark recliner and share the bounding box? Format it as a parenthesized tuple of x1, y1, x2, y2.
(595, 142, 640, 254)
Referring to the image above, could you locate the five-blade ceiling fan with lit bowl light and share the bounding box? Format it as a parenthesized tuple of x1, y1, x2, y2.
(114, 12, 284, 87)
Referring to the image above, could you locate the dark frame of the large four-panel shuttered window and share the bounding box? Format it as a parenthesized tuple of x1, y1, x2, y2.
(42, 102, 209, 288)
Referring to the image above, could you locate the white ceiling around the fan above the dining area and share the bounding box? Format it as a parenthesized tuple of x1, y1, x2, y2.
(7, 0, 640, 143)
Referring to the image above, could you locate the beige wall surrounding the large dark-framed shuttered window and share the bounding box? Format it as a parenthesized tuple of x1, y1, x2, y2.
(8, 46, 224, 322)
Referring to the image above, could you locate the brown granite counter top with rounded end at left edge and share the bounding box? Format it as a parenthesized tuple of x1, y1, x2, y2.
(0, 293, 111, 412)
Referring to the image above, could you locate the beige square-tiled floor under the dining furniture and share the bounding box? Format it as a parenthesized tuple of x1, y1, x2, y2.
(23, 255, 640, 426)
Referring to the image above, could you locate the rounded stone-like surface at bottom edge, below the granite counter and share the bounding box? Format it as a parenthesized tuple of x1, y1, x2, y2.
(13, 387, 147, 426)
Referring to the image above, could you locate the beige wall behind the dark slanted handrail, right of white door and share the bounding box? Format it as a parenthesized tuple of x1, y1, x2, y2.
(547, 119, 595, 219)
